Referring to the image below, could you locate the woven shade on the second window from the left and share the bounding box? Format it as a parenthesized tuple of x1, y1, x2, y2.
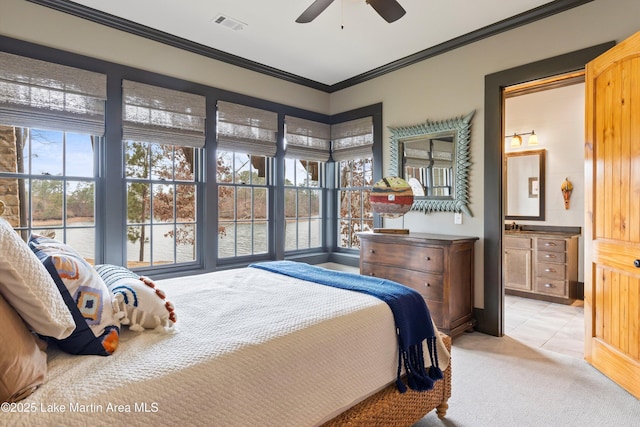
(122, 80, 206, 148)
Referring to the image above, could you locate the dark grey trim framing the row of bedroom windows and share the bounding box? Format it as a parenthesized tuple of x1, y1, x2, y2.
(0, 36, 383, 278)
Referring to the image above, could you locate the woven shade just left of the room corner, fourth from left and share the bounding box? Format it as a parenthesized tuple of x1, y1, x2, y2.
(285, 116, 331, 162)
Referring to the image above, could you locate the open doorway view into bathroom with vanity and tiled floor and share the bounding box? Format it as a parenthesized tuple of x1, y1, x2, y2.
(502, 71, 585, 358)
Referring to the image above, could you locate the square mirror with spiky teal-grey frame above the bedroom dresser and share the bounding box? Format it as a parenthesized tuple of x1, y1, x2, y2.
(389, 111, 475, 216)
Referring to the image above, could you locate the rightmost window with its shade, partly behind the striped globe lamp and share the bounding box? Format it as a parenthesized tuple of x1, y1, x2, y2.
(331, 117, 373, 249)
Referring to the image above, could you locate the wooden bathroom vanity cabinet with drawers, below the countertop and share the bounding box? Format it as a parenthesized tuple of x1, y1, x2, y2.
(503, 231, 578, 304)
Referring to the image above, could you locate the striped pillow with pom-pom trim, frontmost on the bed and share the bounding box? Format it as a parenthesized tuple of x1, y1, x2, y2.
(95, 264, 177, 332)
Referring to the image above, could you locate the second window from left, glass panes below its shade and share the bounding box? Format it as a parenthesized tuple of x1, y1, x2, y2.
(125, 141, 197, 268)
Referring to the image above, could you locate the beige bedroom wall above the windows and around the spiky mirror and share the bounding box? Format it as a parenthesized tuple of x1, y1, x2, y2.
(0, 0, 640, 307)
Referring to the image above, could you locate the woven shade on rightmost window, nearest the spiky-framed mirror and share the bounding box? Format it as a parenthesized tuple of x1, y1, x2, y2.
(331, 116, 373, 162)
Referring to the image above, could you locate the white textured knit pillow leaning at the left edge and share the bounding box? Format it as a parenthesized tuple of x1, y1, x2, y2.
(0, 218, 76, 339)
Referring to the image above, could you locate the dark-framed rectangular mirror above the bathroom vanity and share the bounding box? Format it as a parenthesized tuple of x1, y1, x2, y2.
(504, 150, 545, 221)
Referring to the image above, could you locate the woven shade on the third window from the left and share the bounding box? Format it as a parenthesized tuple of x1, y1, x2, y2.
(217, 101, 278, 157)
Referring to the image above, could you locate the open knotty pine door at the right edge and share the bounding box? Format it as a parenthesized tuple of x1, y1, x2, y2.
(584, 32, 640, 398)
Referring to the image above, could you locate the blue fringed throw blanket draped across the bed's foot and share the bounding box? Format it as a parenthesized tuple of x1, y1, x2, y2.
(249, 261, 443, 393)
